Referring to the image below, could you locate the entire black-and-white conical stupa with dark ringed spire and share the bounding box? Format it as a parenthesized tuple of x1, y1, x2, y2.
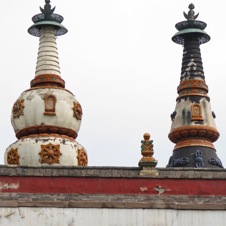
(168, 4, 222, 168)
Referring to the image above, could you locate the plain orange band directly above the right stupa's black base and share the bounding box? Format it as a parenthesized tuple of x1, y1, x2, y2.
(174, 139, 215, 150)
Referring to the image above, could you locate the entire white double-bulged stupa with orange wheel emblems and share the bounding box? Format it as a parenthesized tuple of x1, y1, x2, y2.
(5, 0, 88, 166)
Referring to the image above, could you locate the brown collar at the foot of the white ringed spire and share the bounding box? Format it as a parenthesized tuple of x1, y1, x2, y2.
(31, 74, 65, 88)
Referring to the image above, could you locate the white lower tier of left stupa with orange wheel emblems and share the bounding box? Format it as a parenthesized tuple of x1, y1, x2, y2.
(5, 134, 88, 166)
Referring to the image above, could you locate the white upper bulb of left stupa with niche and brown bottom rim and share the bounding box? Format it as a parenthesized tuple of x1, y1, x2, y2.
(11, 88, 82, 138)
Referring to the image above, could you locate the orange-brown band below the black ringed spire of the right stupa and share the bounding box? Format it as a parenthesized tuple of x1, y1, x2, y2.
(177, 79, 208, 98)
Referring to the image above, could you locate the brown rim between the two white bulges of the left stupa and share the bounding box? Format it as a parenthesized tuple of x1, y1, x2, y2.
(16, 125, 78, 139)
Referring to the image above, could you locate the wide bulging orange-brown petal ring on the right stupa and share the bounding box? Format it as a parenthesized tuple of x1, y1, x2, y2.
(168, 125, 220, 143)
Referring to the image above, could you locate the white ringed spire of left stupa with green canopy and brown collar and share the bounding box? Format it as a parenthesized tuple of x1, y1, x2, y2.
(28, 0, 67, 87)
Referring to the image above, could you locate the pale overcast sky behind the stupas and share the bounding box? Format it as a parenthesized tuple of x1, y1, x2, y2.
(0, 0, 226, 167)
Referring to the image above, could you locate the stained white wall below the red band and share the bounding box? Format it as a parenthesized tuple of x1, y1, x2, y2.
(0, 207, 226, 226)
